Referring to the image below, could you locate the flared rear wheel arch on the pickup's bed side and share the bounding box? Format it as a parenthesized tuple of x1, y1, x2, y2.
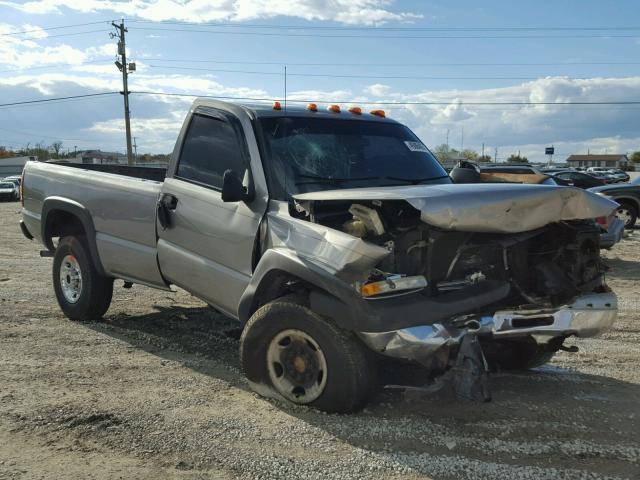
(40, 197, 106, 275)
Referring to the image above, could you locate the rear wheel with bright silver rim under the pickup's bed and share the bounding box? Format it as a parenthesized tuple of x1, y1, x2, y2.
(53, 237, 113, 321)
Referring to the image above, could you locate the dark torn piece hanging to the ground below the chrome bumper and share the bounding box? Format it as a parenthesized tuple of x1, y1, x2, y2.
(452, 332, 491, 402)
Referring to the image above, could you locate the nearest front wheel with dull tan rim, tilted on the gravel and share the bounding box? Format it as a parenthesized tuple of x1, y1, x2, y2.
(240, 297, 377, 413)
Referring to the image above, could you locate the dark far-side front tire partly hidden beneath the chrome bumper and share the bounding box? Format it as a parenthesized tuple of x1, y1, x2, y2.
(482, 339, 556, 371)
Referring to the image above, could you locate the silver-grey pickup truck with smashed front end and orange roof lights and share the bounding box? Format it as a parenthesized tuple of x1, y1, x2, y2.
(21, 99, 617, 412)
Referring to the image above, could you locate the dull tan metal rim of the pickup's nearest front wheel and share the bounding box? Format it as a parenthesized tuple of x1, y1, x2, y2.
(267, 330, 327, 403)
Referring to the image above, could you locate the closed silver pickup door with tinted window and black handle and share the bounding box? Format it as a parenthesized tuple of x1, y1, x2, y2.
(157, 108, 265, 317)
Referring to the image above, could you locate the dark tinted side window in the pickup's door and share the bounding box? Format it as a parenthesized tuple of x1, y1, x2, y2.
(176, 114, 248, 188)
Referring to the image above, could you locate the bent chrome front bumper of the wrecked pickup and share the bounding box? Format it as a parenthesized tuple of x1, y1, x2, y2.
(358, 293, 618, 361)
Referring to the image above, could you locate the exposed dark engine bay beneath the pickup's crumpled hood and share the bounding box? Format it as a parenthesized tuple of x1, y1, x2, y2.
(295, 200, 604, 306)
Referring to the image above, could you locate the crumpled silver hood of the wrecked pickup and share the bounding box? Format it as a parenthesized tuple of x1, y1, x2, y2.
(293, 184, 618, 233)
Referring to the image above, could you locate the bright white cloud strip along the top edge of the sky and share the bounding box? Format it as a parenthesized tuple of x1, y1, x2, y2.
(0, 0, 422, 25)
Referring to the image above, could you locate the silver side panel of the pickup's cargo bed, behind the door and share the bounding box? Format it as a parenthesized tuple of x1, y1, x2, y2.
(23, 162, 165, 286)
